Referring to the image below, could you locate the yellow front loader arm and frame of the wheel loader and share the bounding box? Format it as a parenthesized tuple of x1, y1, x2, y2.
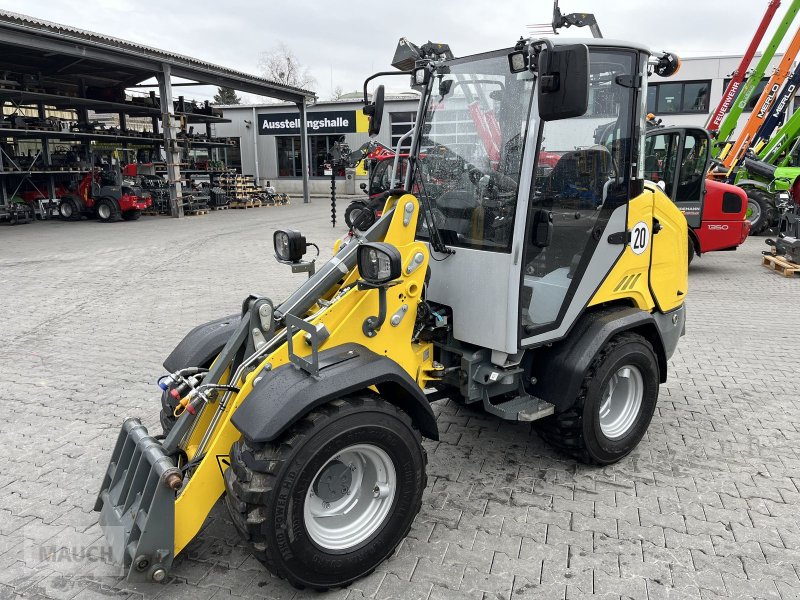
(174, 194, 433, 555)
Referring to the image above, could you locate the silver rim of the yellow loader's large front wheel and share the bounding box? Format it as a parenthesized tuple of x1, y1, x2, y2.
(303, 444, 397, 550)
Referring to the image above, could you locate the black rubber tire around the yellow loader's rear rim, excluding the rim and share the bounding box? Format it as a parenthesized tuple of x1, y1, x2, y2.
(536, 333, 659, 465)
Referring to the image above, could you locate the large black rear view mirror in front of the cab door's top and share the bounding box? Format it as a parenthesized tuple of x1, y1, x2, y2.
(538, 44, 589, 121)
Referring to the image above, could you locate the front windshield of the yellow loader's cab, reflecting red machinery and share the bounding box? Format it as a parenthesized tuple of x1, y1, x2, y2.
(414, 51, 533, 252)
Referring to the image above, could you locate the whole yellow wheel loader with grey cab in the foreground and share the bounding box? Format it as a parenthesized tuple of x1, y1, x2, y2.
(95, 39, 688, 589)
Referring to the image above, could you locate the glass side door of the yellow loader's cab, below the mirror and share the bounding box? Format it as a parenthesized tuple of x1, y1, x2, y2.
(520, 48, 642, 347)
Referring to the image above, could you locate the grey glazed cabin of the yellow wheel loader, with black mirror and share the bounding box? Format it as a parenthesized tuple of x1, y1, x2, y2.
(406, 39, 668, 357)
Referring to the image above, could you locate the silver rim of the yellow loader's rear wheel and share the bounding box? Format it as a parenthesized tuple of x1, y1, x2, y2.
(600, 365, 644, 440)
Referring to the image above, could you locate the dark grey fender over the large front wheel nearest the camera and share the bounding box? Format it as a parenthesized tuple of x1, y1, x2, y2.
(231, 344, 439, 443)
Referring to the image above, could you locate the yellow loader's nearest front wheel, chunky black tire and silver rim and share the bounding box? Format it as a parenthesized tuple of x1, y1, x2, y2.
(225, 396, 427, 590)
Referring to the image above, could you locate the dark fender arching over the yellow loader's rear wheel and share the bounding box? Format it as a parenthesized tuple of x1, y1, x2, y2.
(528, 305, 685, 412)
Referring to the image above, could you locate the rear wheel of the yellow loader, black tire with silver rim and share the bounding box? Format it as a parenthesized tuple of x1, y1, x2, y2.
(537, 333, 659, 465)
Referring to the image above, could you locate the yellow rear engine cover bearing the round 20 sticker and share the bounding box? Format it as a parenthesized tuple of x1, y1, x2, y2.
(589, 186, 689, 312)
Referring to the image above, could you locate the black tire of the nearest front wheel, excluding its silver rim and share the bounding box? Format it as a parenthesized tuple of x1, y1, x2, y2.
(225, 396, 427, 590)
